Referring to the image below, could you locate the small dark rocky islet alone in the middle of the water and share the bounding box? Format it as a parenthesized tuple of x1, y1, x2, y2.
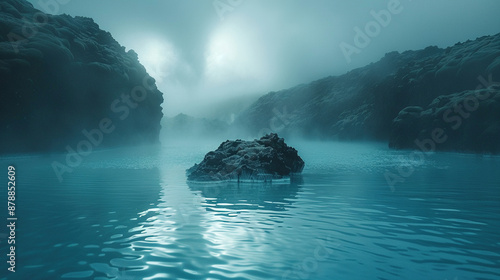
(187, 133, 304, 181)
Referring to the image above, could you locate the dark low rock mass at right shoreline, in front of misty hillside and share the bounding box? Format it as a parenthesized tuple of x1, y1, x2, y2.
(389, 84, 500, 154)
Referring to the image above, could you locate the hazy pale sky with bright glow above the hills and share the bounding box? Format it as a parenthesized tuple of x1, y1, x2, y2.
(30, 0, 500, 116)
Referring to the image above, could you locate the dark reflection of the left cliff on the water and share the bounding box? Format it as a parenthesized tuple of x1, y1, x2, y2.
(0, 164, 160, 279)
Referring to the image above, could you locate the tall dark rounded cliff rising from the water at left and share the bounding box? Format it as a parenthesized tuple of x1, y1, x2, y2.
(0, 0, 163, 153)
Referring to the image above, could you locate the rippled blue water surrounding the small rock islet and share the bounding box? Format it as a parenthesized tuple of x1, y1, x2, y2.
(0, 141, 500, 280)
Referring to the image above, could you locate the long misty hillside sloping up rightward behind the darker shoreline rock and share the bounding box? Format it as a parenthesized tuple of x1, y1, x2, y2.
(237, 34, 500, 153)
